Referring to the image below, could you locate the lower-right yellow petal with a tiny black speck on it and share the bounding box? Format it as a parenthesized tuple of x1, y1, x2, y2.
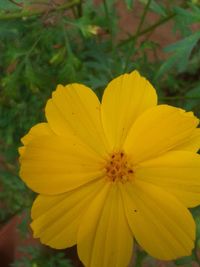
(121, 181, 195, 260)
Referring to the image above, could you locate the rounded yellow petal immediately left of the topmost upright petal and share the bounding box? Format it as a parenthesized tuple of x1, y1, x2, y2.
(45, 84, 107, 155)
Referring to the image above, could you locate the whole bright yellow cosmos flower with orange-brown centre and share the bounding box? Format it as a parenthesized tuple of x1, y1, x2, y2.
(20, 71, 200, 267)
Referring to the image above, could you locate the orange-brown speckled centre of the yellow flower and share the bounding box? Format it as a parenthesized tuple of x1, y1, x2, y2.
(106, 151, 134, 183)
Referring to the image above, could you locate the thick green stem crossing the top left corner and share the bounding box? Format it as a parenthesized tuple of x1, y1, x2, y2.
(0, 0, 80, 20)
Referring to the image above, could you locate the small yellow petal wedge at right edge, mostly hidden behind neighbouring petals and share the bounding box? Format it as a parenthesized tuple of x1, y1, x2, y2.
(175, 128, 200, 152)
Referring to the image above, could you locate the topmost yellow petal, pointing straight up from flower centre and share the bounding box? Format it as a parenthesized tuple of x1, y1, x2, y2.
(101, 71, 157, 150)
